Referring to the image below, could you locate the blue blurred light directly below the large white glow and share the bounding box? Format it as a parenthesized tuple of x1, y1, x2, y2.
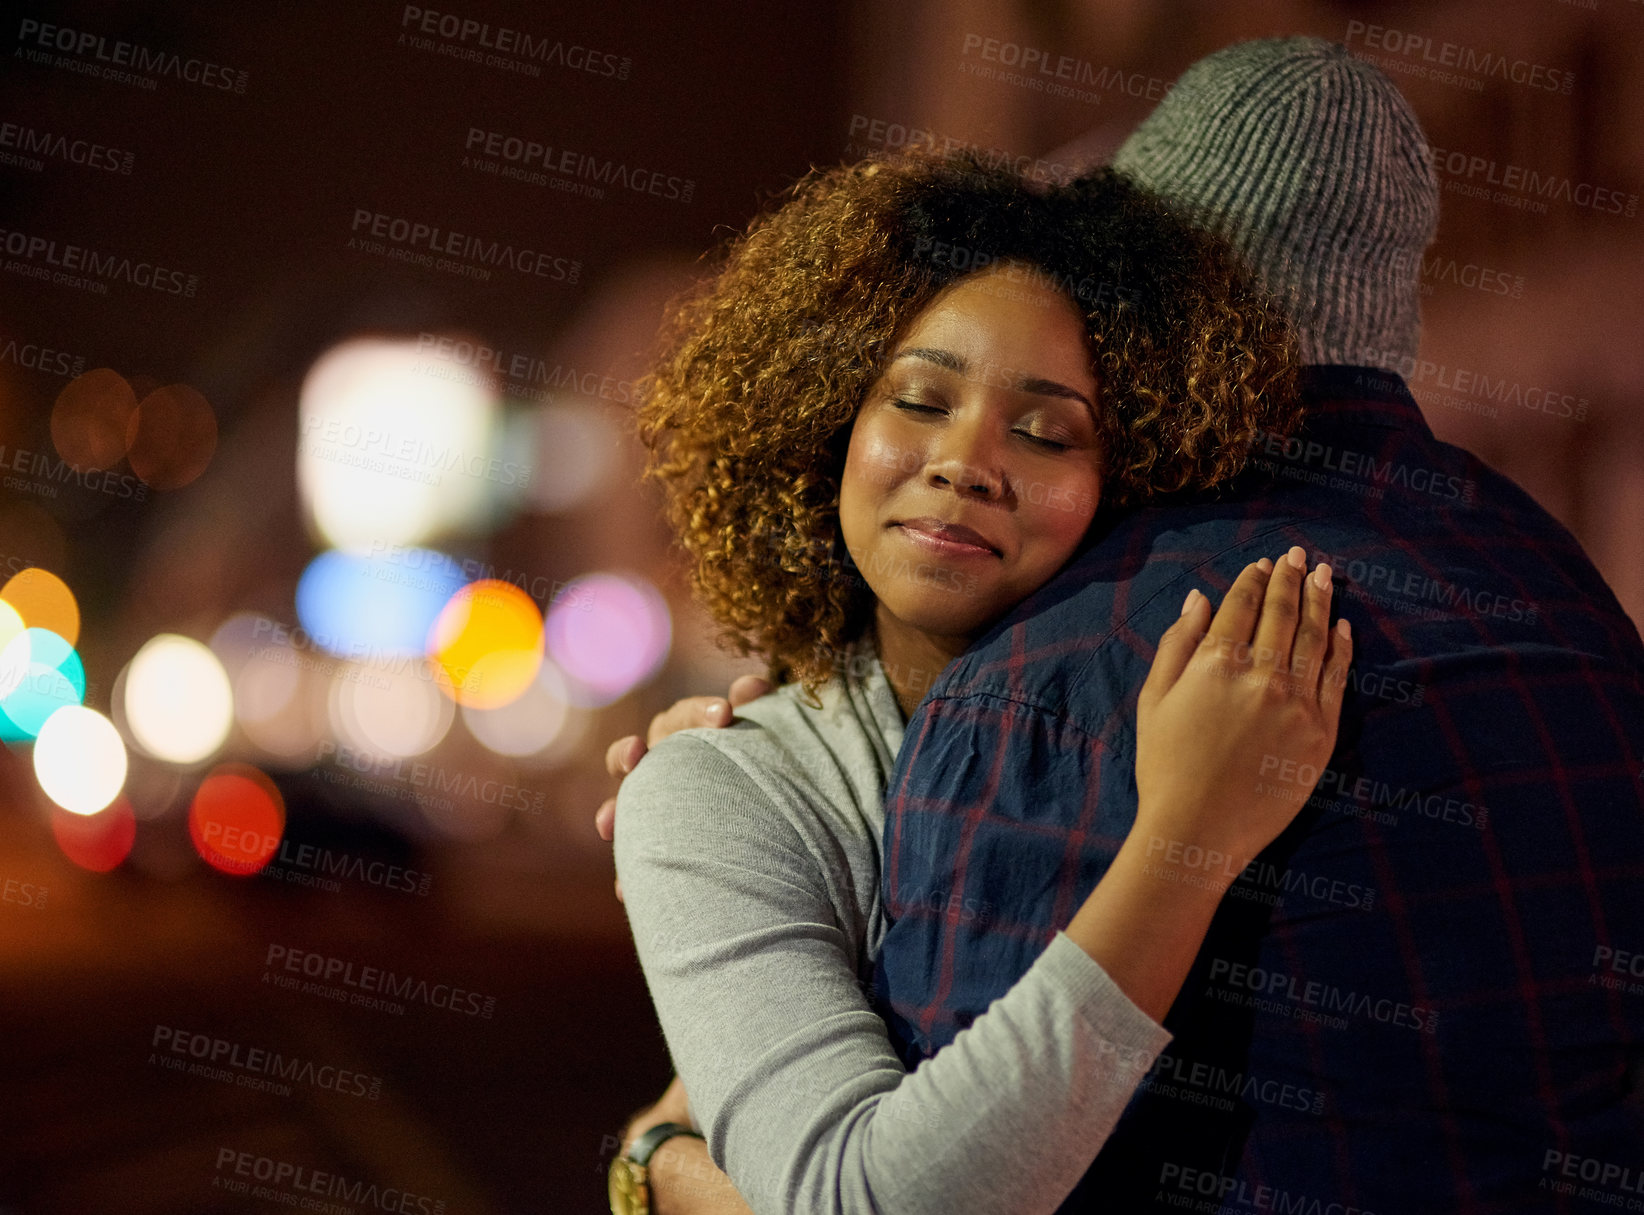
(298, 546, 464, 658)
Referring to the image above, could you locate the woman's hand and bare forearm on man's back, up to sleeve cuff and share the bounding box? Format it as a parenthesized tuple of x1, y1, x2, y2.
(1067, 547, 1353, 1021)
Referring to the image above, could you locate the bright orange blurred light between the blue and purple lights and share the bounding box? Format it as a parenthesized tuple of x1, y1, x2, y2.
(427, 579, 543, 709)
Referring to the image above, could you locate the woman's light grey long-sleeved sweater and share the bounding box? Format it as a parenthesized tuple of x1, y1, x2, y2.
(617, 651, 1171, 1215)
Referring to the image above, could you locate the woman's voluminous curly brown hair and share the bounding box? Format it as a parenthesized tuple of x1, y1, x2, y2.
(638, 153, 1300, 697)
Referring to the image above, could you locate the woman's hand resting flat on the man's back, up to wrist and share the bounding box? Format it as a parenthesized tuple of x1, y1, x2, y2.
(1134, 547, 1353, 888)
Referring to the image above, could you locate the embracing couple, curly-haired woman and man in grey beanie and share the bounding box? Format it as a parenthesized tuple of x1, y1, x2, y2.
(600, 38, 1644, 1215)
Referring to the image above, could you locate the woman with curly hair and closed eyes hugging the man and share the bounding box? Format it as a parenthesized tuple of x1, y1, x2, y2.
(615, 158, 1350, 1215)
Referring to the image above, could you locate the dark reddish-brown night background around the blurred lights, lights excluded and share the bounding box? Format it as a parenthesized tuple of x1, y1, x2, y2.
(0, 0, 1644, 1215)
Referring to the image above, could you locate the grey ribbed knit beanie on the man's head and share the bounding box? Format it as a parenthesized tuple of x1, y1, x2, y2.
(1113, 38, 1439, 375)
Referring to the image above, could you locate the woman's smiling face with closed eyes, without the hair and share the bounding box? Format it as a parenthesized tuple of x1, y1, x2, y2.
(838, 266, 1101, 640)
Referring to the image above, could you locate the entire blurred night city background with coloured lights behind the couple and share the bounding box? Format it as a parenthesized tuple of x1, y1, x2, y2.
(0, 0, 1644, 1215)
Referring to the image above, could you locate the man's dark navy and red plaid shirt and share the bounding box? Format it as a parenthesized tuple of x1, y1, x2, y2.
(875, 367, 1644, 1215)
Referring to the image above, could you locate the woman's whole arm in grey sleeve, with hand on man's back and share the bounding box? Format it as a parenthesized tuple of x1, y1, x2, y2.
(617, 562, 1346, 1215)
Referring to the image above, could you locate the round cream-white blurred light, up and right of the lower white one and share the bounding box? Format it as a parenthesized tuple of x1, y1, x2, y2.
(125, 633, 233, 763)
